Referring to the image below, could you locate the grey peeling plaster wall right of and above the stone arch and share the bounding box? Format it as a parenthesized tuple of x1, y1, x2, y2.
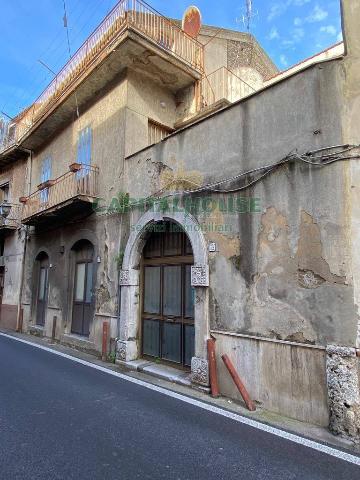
(125, 61, 357, 425)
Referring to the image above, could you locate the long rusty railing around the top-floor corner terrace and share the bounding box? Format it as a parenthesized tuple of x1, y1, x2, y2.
(0, 0, 203, 152)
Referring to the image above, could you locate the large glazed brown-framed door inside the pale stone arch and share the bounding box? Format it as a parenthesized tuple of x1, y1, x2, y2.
(141, 221, 195, 368)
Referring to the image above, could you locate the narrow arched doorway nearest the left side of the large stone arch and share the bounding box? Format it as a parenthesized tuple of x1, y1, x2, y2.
(71, 240, 95, 337)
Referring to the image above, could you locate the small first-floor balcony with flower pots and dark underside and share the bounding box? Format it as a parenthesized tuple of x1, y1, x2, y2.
(21, 164, 99, 226)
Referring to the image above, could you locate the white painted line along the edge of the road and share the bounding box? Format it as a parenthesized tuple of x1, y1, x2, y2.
(0, 332, 360, 465)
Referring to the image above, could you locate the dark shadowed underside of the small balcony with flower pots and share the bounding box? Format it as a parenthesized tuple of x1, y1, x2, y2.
(21, 195, 97, 227)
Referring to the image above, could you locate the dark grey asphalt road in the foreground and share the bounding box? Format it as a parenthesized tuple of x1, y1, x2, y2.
(0, 336, 360, 480)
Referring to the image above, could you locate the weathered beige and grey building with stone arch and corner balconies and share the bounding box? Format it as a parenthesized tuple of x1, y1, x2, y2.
(0, 0, 360, 437)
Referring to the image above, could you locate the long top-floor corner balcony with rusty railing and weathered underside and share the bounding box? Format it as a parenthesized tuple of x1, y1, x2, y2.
(0, 0, 203, 158)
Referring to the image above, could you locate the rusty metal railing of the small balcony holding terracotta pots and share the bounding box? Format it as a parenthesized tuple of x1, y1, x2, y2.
(22, 165, 99, 220)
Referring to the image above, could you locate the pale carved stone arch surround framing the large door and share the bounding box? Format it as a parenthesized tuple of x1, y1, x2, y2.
(117, 211, 209, 385)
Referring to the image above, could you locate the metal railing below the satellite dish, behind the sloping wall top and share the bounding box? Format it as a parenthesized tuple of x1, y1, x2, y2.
(197, 67, 255, 111)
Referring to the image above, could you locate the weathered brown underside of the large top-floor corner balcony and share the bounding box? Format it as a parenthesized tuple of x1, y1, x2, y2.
(22, 28, 201, 154)
